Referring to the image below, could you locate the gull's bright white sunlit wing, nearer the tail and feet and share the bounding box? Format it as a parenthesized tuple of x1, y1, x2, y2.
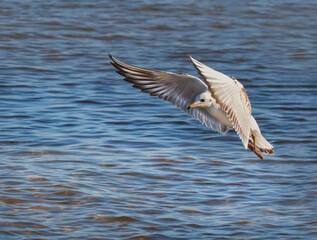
(191, 57, 251, 149)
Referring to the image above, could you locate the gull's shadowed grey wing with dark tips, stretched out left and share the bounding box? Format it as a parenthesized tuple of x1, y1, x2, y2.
(109, 54, 228, 134)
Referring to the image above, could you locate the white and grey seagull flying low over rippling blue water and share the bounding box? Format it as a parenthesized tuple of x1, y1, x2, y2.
(108, 53, 274, 160)
